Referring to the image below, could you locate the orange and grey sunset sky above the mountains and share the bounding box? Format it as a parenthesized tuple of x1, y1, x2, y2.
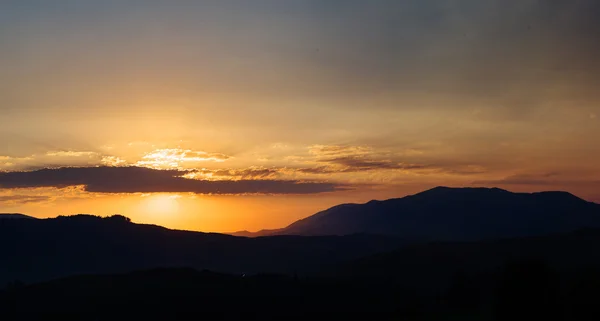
(0, 0, 600, 232)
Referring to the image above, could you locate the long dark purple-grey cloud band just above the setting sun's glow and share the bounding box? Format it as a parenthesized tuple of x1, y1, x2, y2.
(0, 167, 347, 194)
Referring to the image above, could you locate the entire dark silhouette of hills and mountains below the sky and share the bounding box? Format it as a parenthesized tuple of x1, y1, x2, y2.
(0, 187, 600, 320)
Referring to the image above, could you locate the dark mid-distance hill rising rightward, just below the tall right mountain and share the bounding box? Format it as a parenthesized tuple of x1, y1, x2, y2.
(330, 229, 600, 291)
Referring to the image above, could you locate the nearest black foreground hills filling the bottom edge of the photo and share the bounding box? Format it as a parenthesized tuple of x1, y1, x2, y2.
(0, 230, 600, 320)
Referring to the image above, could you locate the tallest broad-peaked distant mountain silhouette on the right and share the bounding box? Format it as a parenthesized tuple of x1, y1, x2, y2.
(233, 187, 600, 241)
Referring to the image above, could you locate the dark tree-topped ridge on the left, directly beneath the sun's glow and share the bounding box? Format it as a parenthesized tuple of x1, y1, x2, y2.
(0, 215, 403, 288)
